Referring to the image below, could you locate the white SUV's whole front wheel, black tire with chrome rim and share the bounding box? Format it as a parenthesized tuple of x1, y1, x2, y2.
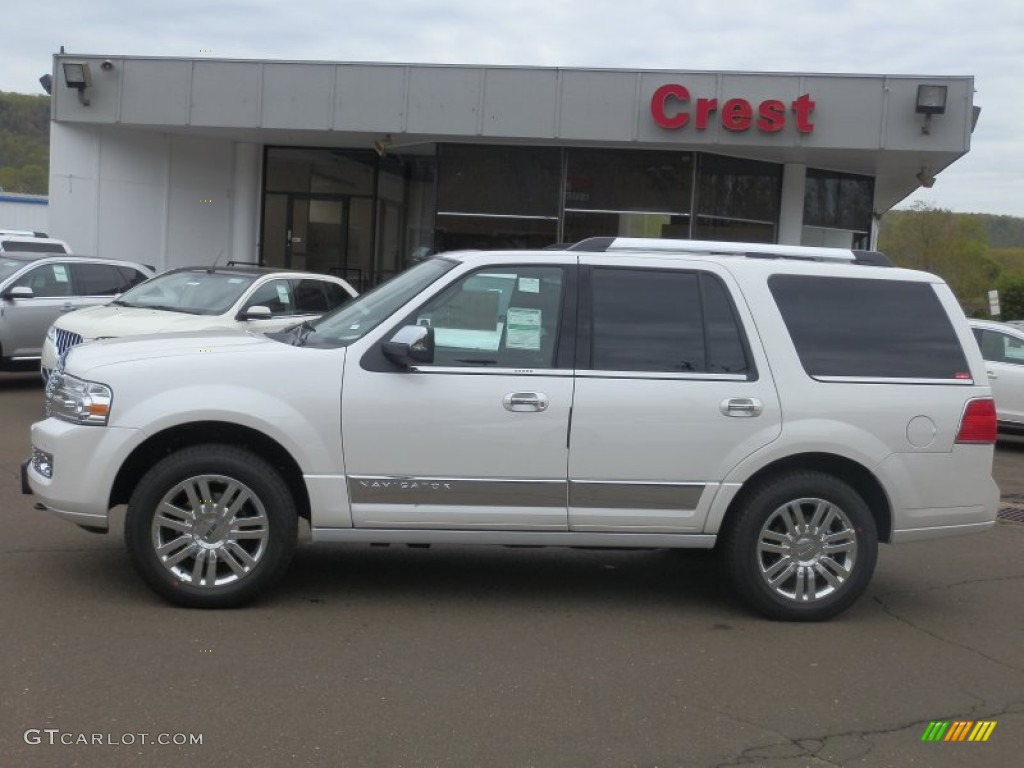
(125, 444, 298, 608)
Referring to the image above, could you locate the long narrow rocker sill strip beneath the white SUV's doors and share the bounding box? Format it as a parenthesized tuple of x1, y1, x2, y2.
(312, 527, 716, 549)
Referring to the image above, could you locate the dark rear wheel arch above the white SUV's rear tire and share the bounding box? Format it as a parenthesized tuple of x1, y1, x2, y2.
(719, 453, 892, 542)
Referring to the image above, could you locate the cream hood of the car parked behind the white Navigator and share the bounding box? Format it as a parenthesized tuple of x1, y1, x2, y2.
(56, 304, 236, 341)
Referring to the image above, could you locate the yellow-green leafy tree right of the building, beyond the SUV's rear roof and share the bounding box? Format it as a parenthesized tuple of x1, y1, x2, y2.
(879, 204, 1001, 314)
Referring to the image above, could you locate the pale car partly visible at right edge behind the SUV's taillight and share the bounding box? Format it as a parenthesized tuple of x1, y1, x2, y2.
(970, 319, 1024, 434)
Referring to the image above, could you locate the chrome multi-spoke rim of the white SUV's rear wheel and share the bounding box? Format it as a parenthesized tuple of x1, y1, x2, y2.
(757, 498, 857, 603)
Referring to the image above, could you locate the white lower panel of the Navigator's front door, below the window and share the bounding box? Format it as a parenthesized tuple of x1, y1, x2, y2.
(342, 366, 572, 530)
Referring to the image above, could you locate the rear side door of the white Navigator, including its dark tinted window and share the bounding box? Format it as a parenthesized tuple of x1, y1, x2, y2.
(569, 262, 781, 534)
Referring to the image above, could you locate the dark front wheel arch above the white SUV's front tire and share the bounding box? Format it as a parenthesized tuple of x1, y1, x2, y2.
(109, 421, 310, 520)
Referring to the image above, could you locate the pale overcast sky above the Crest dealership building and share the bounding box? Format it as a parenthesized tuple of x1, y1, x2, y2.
(0, 0, 1024, 217)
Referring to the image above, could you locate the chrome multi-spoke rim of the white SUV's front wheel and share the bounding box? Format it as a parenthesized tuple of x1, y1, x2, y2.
(151, 474, 270, 588)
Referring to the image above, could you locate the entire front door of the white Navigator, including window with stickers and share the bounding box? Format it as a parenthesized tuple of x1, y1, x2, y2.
(342, 264, 573, 530)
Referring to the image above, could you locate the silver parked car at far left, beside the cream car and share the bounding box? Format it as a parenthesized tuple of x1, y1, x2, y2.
(0, 252, 153, 371)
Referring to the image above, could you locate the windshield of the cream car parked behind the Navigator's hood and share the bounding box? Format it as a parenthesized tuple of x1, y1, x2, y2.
(114, 270, 259, 314)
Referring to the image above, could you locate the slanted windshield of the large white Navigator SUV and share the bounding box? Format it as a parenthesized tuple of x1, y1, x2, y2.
(299, 258, 456, 346)
